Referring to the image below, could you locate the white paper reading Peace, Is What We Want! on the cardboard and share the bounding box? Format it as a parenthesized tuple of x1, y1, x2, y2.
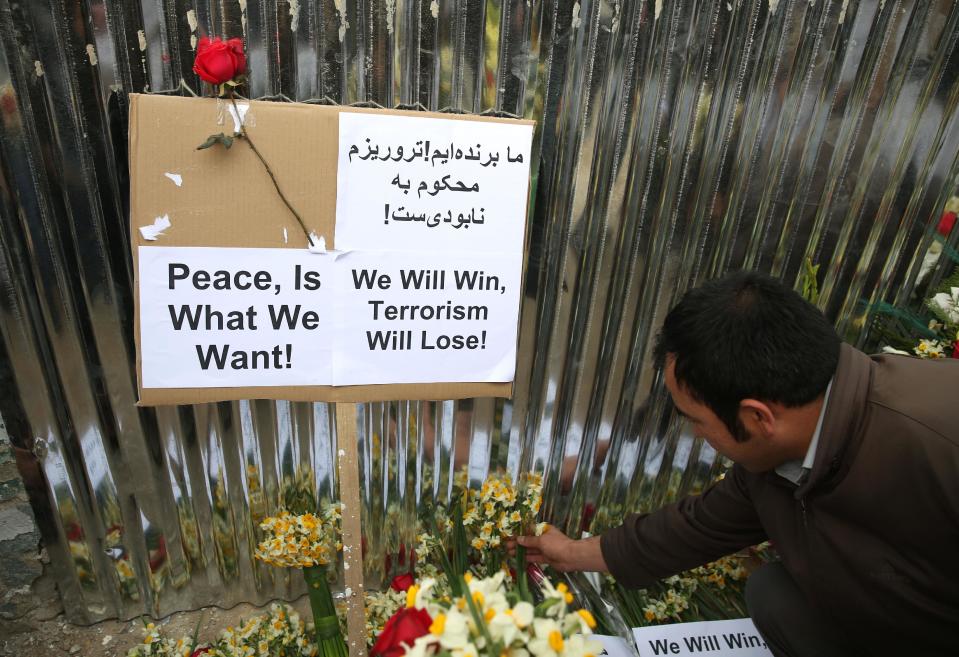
(138, 246, 335, 388)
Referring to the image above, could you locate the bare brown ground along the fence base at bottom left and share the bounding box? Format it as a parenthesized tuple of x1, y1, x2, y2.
(0, 596, 310, 657)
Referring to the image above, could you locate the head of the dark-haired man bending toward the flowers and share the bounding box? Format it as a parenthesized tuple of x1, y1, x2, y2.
(656, 272, 840, 471)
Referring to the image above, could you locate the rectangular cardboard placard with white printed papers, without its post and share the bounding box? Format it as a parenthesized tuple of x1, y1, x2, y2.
(130, 95, 532, 405)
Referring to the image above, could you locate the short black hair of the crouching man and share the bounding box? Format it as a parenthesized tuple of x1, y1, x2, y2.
(655, 271, 841, 440)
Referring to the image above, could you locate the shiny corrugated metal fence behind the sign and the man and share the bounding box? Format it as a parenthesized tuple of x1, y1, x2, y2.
(0, 0, 959, 622)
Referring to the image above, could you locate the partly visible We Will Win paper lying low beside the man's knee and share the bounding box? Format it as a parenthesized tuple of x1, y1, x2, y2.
(633, 618, 772, 657)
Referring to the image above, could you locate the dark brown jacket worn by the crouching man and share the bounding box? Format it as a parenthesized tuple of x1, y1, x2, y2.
(601, 345, 959, 655)
